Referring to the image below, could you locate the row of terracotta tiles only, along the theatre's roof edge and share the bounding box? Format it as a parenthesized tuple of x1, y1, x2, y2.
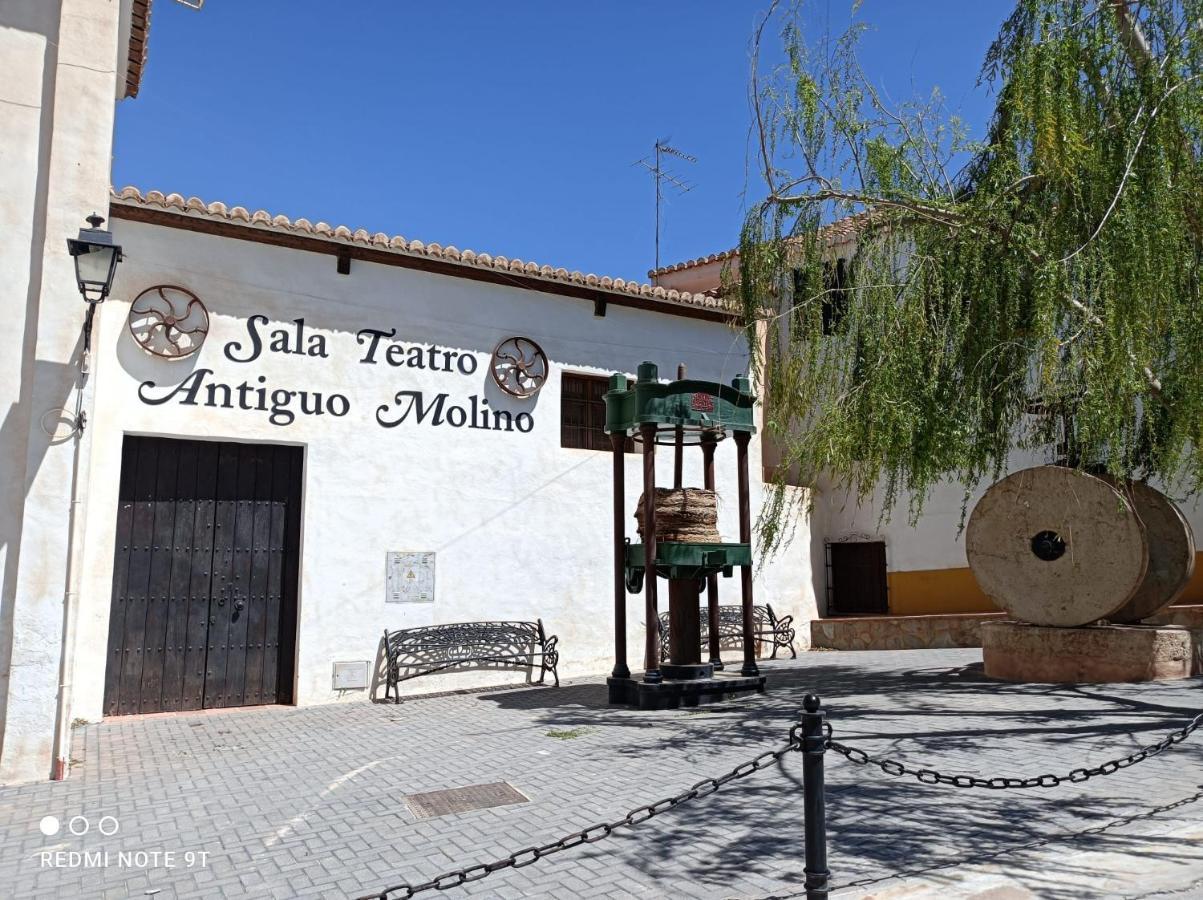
(112, 186, 735, 314)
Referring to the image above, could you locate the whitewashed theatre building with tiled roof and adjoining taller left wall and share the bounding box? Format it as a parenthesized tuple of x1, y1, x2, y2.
(0, 0, 816, 783)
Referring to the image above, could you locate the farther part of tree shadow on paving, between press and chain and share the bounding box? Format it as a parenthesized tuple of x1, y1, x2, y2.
(480, 653, 1203, 754)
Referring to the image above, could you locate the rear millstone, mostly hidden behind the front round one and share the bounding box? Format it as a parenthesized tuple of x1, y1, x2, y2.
(1109, 481, 1195, 623)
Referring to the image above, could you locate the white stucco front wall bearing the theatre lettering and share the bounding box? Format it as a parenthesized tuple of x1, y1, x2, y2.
(73, 221, 814, 720)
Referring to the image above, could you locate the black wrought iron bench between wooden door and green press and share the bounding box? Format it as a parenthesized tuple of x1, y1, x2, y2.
(384, 618, 559, 703)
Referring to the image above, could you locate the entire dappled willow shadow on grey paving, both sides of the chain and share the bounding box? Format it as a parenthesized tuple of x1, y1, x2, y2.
(481, 655, 1203, 898)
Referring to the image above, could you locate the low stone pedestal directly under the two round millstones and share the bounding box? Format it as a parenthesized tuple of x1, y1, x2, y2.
(982, 622, 1195, 685)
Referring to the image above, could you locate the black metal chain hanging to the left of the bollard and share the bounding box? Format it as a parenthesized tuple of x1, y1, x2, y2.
(358, 726, 802, 900)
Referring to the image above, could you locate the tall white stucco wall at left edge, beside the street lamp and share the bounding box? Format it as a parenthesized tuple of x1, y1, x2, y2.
(0, 0, 128, 783)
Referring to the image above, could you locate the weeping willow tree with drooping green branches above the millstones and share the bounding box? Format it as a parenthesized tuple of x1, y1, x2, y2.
(735, 0, 1203, 546)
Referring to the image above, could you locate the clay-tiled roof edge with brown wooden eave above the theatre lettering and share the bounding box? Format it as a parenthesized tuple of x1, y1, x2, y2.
(112, 186, 735, 319)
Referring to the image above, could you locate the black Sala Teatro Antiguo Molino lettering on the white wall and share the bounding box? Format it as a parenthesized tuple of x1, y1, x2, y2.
(138, 315, 534, 433)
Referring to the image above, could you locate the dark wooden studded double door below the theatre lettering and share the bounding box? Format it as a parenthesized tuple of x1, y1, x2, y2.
(105, 436, 303, 716)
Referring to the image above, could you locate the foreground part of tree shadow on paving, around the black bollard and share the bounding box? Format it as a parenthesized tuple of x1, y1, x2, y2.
(558, 760, 1203, 900)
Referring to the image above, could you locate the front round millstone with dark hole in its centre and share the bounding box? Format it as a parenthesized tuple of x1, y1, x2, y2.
(965, 466, 1149, 628)
